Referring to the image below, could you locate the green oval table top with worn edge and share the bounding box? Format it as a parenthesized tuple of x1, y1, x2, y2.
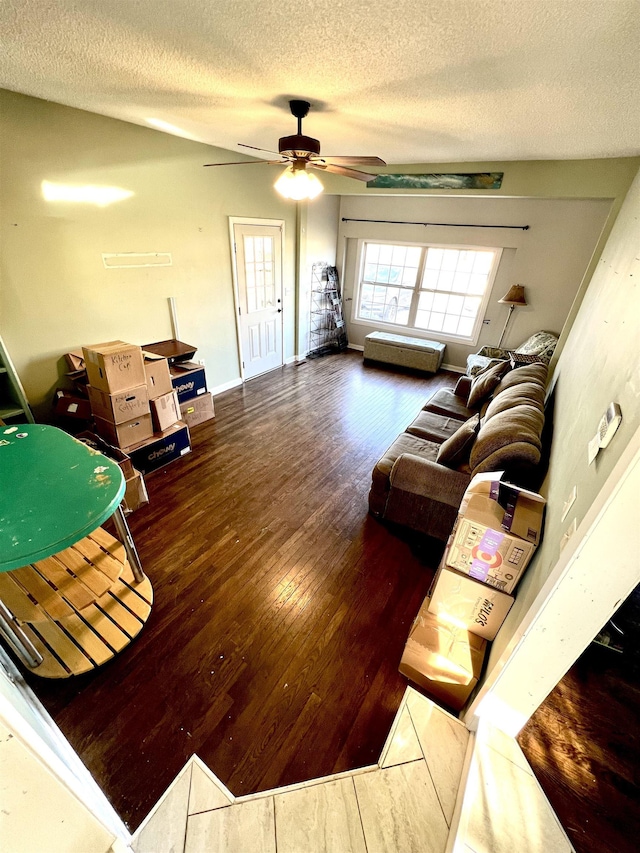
(0, 424, 125, 572)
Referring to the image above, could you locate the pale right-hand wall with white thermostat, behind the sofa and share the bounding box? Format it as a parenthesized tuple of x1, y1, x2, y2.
(489, 165, 640, 671)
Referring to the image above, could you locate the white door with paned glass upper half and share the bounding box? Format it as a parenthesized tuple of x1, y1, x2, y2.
(233, 223, 282, 379)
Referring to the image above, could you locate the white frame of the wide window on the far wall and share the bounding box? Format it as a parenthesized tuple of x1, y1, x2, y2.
(350, 237, 502, 346)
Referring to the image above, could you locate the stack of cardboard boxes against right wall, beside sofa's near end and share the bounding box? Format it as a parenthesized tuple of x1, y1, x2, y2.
(400, 472, 545, 710)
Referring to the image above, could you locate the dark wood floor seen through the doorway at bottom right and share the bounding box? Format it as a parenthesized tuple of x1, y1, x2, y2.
(518, 588, 640, 853)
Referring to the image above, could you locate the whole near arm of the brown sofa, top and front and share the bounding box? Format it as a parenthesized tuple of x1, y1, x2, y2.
(384, 453, 470, 542)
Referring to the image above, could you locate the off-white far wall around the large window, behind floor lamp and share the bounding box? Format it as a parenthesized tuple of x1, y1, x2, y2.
(339, 196, 611, 367)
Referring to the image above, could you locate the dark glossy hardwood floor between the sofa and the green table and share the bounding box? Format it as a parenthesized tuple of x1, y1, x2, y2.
(29, 352, 457, 830)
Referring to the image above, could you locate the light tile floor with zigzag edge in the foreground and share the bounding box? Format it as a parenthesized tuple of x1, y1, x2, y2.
(133, 687, 572, 853)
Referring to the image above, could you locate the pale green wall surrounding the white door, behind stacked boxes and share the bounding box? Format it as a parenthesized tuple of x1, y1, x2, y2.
(0, 91, 295, 417)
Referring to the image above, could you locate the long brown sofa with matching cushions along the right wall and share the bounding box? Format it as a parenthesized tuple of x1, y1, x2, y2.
(369, 362, 548, 541)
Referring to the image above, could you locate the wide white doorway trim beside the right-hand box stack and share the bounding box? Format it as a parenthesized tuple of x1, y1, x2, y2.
(463, 427, 640, 735)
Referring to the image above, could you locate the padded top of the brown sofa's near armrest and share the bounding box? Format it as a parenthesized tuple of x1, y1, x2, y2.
(389, 453, 470, 502)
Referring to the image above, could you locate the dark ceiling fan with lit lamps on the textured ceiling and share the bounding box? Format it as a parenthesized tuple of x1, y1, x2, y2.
(205, 100, 387, 200)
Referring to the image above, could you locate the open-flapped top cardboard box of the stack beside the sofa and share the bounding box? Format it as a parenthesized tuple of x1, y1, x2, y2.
(447, 472, 545, 592)
